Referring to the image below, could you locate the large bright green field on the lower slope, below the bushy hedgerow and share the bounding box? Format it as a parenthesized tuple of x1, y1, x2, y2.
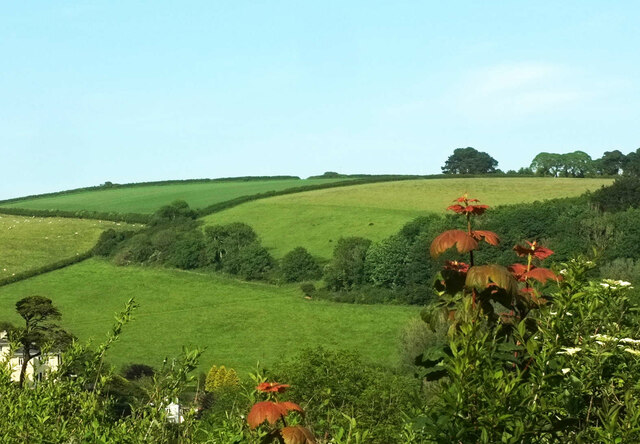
(0, 259, 418, 373)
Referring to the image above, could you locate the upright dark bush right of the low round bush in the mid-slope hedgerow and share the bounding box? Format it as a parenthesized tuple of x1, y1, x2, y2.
(324, 237, 371, 291)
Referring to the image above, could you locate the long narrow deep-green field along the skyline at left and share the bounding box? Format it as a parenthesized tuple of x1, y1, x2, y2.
(0, 179, 344, 213)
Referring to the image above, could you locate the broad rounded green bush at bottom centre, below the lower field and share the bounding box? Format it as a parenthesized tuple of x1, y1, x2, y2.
(274, 347, 419, 443)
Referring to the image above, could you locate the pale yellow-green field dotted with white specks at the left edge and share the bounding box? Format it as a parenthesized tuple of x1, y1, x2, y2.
(0, 214, 135, 279)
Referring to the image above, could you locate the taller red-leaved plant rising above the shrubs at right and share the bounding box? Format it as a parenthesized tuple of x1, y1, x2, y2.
(416, 194, 560, 380)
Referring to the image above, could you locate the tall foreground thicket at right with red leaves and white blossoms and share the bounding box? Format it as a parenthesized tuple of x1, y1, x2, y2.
(407, 196, 640, 443)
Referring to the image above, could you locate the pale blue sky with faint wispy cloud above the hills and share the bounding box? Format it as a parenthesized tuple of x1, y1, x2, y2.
(0, 0, 640, 199)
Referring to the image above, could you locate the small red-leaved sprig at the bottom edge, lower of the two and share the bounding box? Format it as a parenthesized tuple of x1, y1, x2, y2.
(247, 382, 316, 444)
